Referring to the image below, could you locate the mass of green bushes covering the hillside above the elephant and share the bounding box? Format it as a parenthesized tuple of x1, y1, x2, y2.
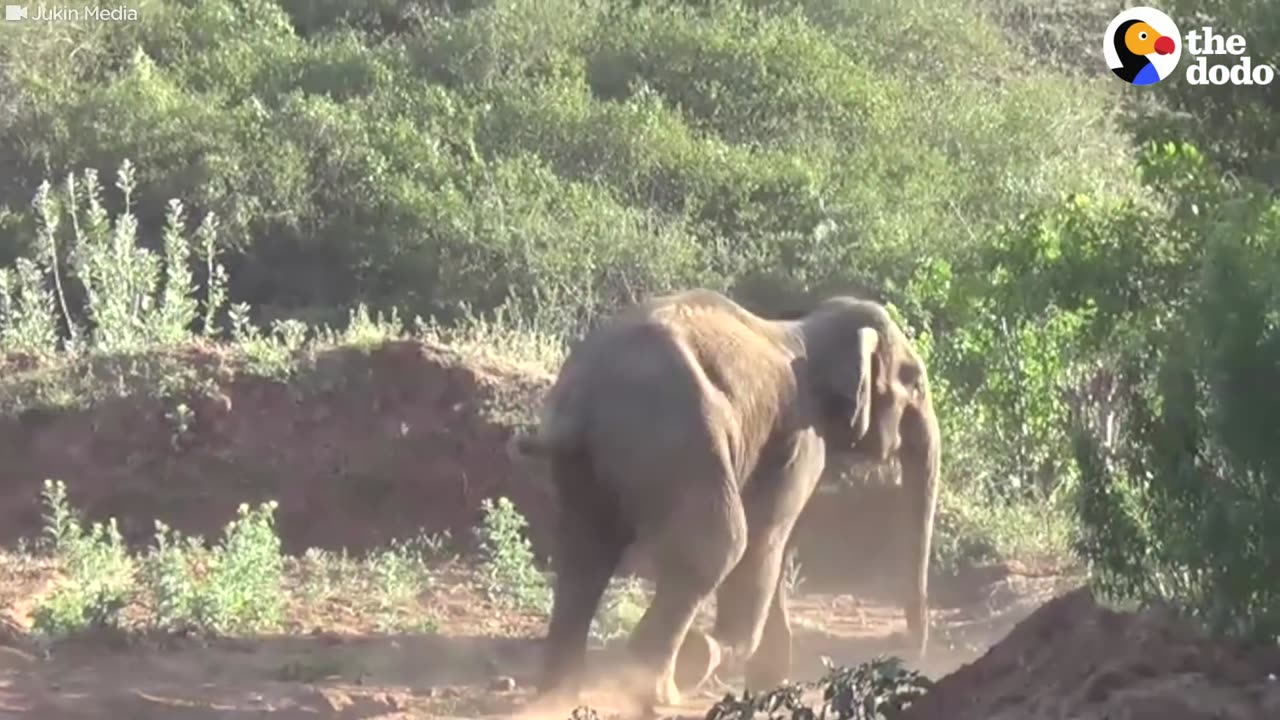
(0, 0, 1132, 323)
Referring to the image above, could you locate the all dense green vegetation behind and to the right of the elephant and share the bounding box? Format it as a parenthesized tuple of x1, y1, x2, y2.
(0, 0, 1280, 633)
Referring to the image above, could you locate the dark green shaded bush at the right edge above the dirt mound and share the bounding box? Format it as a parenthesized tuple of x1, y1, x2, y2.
(1076, 154, 1280, 639)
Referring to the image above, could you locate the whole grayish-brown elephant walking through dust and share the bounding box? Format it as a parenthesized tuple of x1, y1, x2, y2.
(515, 291, 941, 707)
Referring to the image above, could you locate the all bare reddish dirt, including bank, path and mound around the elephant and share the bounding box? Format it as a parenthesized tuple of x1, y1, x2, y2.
(0, 342, 1280, 720)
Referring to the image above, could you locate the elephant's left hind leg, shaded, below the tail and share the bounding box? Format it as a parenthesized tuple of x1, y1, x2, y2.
(540, 450, 631, 703)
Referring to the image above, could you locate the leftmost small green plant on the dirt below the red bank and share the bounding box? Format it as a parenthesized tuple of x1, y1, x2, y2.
(32, 480, 134, 637)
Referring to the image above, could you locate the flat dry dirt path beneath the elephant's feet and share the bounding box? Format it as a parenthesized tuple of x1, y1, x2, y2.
(0, 566, 1071, 720)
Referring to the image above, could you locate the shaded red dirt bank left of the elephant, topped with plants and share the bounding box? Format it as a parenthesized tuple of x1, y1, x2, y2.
(0, 341, 552, 551)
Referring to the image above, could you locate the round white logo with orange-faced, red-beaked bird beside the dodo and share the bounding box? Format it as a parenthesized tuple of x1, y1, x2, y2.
(1102, 8, 1183, 85)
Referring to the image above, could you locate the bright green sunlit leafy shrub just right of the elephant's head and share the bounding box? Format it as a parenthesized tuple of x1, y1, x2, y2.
(901, 145, 1228, 569)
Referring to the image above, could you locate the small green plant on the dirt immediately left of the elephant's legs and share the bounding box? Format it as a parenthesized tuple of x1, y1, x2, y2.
(477, 497, 552, 612)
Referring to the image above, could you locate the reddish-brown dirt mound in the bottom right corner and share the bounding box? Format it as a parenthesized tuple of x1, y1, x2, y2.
(901, 589, 1280, 720)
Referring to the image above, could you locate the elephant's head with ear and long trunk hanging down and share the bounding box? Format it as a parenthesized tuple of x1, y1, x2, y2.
(799, 297, 942, 653)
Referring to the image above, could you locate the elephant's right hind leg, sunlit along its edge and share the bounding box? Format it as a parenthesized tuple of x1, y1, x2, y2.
(630, 466, 746, 705)
